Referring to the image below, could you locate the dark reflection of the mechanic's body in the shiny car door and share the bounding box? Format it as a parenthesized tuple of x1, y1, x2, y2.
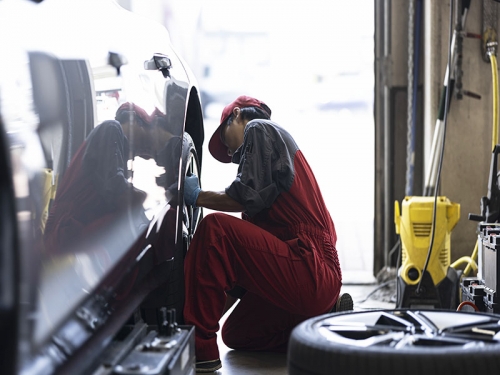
(44, 121, 149, 255)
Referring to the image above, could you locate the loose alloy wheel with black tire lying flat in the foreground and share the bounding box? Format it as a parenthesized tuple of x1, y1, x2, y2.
(287, 310, 500, 375)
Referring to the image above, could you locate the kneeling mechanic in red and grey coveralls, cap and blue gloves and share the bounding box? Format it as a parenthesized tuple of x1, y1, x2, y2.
(184, 96, 352, 372)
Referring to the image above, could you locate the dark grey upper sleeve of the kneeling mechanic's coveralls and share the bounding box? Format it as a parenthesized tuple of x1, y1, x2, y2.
(226, 125, 279, 217)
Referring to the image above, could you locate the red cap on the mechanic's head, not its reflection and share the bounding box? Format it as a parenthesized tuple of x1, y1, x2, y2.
(208, 95, 271, 163)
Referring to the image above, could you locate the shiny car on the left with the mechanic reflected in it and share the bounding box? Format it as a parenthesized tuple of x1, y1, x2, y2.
(0, 0, 204, 374)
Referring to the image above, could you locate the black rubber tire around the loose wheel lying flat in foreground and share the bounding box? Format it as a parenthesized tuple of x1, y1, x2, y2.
(288, 314, 500, 375)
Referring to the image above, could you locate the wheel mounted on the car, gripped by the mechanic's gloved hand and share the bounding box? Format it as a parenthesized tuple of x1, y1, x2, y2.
(167, 133, 203, 324)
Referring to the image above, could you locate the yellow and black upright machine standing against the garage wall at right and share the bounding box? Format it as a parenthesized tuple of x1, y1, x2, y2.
(394, 196, 460, 308)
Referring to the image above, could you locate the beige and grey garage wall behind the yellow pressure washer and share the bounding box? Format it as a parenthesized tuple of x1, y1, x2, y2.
(374, 0, 499, 274)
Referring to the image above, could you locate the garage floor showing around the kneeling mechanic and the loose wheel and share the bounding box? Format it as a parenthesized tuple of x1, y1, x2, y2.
(209, 284, 395, 375)
